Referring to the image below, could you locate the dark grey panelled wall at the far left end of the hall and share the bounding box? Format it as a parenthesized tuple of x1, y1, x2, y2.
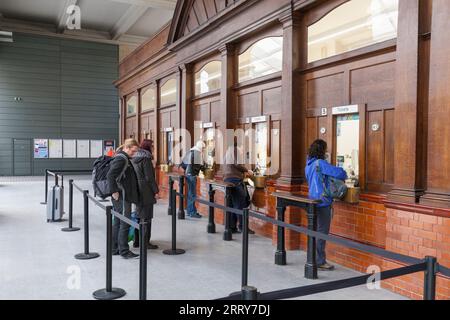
(0, 34, 119, 175)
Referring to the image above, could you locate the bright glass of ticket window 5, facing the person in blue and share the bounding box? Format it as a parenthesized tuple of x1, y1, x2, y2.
(336, 114, 359, 178)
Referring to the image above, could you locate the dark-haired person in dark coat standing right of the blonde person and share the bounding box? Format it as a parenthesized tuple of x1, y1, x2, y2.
(131, 140, 159, 249)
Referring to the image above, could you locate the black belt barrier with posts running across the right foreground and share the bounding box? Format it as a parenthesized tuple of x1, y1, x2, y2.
(169, 179, 444, 300)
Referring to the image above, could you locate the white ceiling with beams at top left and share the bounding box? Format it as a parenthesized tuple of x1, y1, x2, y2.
(0, 0, 176, 42)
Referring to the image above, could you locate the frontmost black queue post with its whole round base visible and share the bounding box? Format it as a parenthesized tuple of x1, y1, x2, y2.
(92, 206, 126, 300)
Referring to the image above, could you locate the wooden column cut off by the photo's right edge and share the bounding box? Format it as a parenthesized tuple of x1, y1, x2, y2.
(421, 0, 450, 208)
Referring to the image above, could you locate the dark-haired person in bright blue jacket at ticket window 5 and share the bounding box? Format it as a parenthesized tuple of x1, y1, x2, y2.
(305, 139, 347, 271)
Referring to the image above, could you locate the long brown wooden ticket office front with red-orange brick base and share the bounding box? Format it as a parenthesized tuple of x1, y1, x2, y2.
(116, 0, 450, 298)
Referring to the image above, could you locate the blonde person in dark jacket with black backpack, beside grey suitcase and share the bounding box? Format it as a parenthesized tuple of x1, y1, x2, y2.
(107, 139, 139, 259)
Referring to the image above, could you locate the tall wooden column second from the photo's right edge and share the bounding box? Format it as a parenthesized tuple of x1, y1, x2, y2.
(388, 0, 430, 203)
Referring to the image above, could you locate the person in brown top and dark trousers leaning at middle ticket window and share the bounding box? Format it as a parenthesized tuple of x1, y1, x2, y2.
(223, 143, 255, 234)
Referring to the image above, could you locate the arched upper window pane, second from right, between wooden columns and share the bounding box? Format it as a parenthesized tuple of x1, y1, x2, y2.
(239, 37, 283, 82)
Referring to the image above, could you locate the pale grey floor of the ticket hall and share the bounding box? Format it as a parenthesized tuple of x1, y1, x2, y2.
(0, 177, 404, 300)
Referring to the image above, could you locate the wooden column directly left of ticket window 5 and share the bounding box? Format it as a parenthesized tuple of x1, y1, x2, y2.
(277, 10, 306, 185)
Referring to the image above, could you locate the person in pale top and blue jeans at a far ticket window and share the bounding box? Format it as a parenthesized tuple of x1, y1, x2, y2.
(182, 140, 205, 219)
